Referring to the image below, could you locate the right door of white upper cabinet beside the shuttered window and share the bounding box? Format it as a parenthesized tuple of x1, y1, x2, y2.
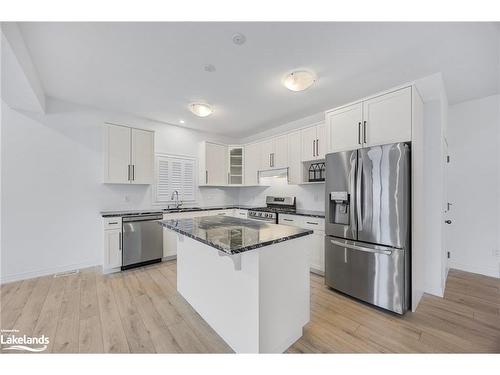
(131, 129, 154, 184)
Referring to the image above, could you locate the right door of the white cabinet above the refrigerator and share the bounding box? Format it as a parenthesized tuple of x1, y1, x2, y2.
(363, 87, 411, 147)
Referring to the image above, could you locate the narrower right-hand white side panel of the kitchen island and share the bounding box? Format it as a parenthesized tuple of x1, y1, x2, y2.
(259, 236, 311, 353)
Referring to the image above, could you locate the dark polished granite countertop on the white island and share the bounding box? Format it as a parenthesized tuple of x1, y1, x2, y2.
(160, 216, 313, 255)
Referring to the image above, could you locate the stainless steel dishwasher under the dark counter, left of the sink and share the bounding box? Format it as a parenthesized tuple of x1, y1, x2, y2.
(122, 214, 163, 270)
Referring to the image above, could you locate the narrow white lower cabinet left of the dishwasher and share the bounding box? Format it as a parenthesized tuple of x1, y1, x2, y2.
(102, 217, 122, 273)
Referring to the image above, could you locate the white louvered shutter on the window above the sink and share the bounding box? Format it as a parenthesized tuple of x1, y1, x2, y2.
(154, 154, 196, 203)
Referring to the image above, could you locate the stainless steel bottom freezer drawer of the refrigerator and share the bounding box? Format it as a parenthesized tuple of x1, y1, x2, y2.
(325, 236, 408, 314)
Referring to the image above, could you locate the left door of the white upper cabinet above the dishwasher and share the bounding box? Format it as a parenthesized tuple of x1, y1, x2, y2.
(104, 124, 130, 183)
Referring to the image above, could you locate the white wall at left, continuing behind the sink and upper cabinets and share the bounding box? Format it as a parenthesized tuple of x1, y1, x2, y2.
(0, 100, 238, 281)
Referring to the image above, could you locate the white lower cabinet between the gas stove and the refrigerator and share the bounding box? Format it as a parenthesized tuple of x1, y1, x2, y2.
(278, 214, 325, 275)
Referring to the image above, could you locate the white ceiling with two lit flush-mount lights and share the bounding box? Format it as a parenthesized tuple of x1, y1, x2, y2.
(20, 22, 500, 137)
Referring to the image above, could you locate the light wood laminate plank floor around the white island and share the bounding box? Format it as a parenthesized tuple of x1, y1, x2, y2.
(0, 261, 500, 353)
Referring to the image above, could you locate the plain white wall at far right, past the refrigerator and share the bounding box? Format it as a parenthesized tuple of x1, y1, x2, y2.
(448, 95, 500, 277)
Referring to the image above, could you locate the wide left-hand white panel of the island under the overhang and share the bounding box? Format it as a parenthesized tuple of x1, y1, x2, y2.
(177, 235, 259, 353)
